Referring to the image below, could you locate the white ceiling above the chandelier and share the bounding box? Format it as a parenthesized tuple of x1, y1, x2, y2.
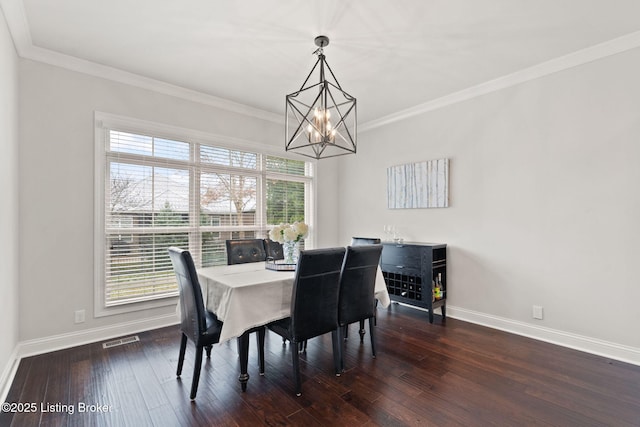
(0, 0, 640, 123)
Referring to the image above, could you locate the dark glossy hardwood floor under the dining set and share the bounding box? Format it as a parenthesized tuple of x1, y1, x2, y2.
(0, 304, 640, 427)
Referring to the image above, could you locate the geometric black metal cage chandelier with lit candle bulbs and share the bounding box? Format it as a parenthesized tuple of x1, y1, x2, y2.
(285, 36, 357, 159)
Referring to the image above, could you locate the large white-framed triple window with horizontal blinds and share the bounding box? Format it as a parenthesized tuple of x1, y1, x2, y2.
(96, 113, 313, 315)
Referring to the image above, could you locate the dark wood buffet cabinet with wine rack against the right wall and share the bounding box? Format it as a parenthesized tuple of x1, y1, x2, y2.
(380, 242, 447, 323)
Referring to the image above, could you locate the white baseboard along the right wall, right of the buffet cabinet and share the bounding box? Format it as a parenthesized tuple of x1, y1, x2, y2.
(447, 305, 640, 366)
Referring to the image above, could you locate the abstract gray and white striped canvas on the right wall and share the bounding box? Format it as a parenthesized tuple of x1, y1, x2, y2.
(387, 159, 449, 209)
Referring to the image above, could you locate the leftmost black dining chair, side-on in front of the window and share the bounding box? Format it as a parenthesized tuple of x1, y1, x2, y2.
(169, 247, 222, 400)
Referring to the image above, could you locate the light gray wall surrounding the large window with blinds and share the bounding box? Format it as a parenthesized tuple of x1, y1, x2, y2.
(19, 60, 337, 341)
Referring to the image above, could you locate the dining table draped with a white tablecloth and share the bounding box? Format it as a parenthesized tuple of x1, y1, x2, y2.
(197, 262, 391, 391)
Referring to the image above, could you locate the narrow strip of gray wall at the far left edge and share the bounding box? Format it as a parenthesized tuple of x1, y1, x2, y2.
(0, 9, 18, 387)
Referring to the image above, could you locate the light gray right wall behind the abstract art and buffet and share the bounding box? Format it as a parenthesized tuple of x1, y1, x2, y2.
(338, 49, 640, 354)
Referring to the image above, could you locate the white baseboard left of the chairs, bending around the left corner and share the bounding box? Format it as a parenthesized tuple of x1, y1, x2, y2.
(0, 313, 178, 402)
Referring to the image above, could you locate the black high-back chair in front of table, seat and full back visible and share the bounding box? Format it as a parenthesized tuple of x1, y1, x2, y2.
(267, 248, 345, 396)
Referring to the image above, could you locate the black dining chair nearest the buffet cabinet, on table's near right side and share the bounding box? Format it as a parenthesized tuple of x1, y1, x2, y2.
(338, 245, 382, 370)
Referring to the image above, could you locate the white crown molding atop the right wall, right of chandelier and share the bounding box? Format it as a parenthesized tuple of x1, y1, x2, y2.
(359, 31, 640, 132)
